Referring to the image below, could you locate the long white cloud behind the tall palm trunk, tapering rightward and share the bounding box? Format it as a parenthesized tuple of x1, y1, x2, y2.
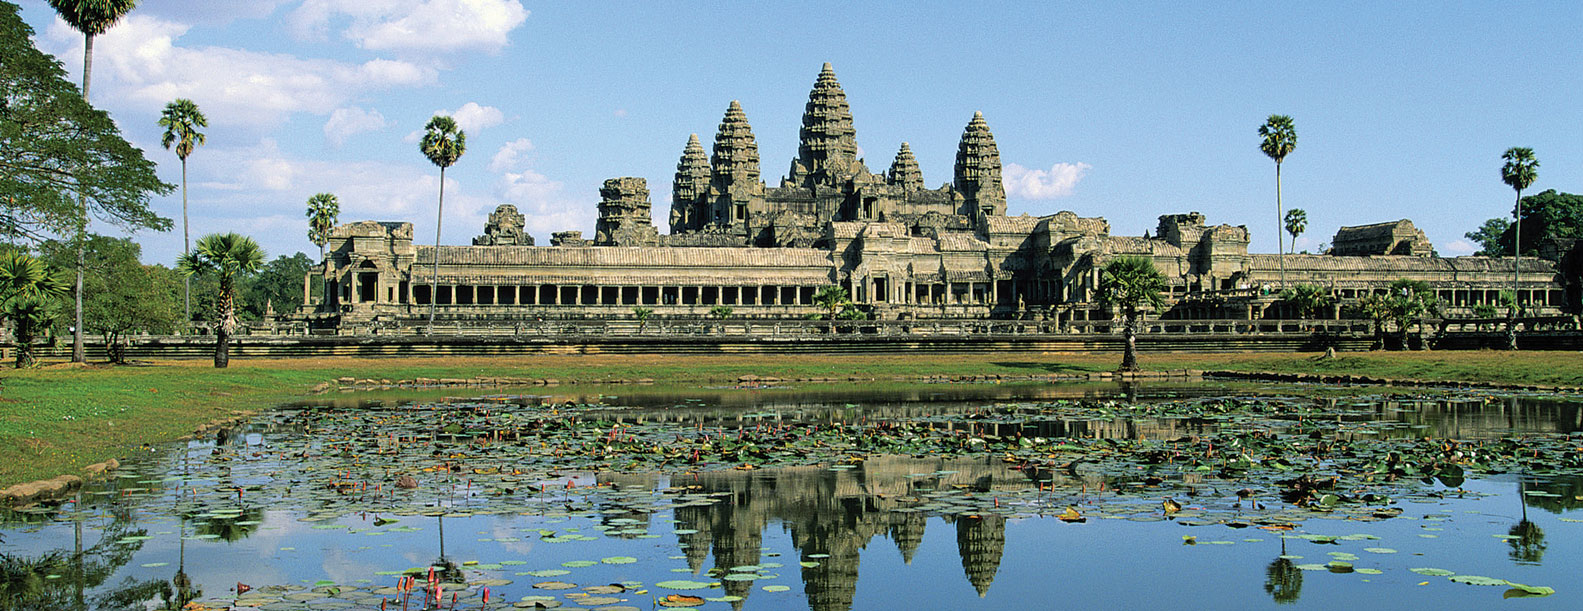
(46, 14, 435, 125)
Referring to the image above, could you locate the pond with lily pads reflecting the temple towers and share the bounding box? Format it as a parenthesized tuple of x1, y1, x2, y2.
(0, 381, 1583, 611)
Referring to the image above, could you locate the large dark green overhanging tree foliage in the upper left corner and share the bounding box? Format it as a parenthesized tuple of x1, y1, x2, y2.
(0, 2, 176, 237)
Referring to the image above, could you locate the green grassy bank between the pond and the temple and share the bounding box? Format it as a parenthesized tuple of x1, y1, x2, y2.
(0, 351, 1583, 486)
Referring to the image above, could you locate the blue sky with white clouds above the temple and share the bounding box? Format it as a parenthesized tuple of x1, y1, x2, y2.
(21, 0, 1583, 263)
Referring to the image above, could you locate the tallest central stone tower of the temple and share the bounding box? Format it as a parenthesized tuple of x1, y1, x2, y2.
(788, 62, 858, 187)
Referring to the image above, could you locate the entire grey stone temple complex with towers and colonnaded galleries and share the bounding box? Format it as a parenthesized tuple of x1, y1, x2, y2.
(302, 63, 1578, 326)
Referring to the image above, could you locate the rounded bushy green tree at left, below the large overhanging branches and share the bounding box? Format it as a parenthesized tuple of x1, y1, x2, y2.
(40, 234, 182, 362)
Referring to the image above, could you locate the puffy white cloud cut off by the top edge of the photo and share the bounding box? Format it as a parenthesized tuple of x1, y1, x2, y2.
(288, 0, 529, 52)
